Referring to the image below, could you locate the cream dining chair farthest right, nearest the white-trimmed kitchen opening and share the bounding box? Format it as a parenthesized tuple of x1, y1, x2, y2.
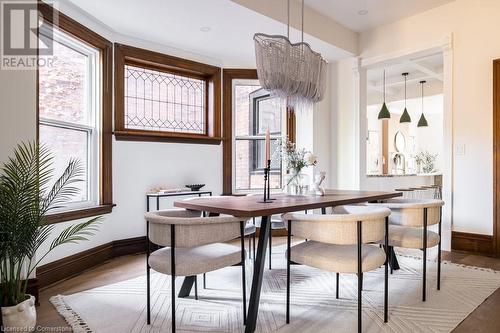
(367, 198, 444, 302)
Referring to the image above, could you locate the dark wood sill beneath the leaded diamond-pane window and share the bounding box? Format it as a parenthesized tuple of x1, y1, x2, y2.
(114, 130, 222, 145)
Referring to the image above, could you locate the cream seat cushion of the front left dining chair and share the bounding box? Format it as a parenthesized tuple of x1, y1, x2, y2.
(149, 243, 246, 276)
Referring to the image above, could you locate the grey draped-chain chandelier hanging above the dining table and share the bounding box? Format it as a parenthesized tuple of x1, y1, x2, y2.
(253, 0, 327, 107)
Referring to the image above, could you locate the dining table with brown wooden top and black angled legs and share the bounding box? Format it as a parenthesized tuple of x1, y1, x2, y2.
(174, 189, 402, 333)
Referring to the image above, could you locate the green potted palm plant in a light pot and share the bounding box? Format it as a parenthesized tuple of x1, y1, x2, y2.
(0, 143, 100, 332)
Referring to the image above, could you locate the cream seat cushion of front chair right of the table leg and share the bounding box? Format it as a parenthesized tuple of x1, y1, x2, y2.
(290, 241, 385, 273)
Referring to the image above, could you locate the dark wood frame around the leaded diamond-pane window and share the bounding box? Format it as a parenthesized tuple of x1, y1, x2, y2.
(114, 44, 222, 144)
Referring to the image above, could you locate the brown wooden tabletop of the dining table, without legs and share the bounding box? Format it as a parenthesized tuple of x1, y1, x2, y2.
(174, 190, 402, 217)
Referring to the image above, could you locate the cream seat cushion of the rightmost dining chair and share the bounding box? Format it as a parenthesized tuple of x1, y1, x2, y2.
(389, 225, 439, 249)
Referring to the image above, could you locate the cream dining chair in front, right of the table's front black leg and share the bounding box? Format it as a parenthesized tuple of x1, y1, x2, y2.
(283, 206, 391, 332)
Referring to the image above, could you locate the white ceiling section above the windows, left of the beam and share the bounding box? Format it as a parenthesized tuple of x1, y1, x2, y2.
(66, 0, 348, 67)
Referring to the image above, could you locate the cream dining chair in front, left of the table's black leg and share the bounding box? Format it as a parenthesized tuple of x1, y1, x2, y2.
(145, 209, 246, 332)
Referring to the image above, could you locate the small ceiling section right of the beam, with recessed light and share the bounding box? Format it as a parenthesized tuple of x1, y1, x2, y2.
(304, 0, 454, 32)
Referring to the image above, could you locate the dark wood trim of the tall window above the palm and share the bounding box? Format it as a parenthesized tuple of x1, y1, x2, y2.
(36, 2, 114, 223)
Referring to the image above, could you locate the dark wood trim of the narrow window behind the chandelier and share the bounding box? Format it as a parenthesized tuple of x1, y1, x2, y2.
(222, 68, 296, 195)
